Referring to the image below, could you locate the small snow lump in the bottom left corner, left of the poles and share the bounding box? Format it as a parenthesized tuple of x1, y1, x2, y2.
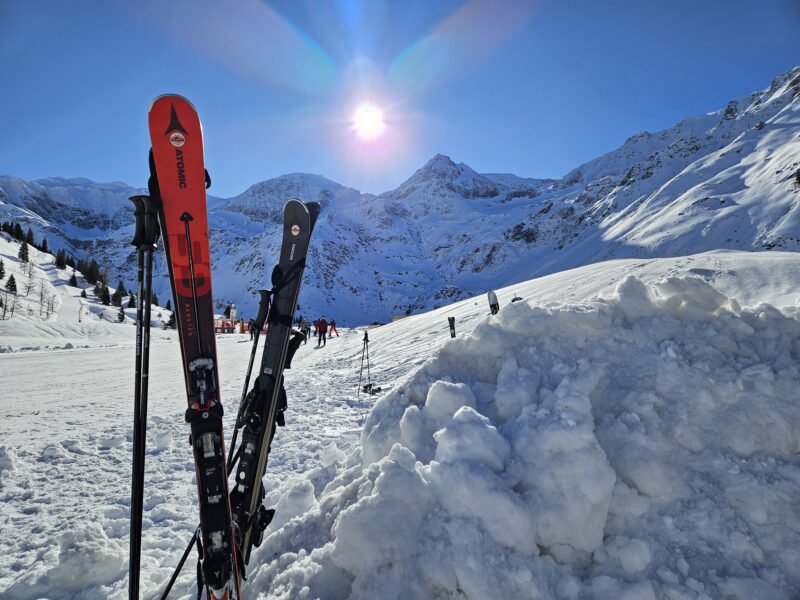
(4, 523, 127, 600)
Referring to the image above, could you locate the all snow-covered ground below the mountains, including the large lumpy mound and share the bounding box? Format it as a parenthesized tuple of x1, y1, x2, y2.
(0, 251, 800, 600)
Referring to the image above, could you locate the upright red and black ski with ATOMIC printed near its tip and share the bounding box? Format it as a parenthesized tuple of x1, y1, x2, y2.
(149, 95, 241, 600)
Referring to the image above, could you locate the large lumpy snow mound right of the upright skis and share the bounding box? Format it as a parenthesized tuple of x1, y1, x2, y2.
(250, 276, 800, 600)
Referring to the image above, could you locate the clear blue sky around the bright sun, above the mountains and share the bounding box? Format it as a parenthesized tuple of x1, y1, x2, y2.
(0, 0, 800, 197)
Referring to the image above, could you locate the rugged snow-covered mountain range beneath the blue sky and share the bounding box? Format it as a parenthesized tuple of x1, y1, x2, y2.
(0, 67, 800, 324)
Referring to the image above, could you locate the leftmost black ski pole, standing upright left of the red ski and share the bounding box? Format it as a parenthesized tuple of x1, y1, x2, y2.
(128, 196, 144, 600)
